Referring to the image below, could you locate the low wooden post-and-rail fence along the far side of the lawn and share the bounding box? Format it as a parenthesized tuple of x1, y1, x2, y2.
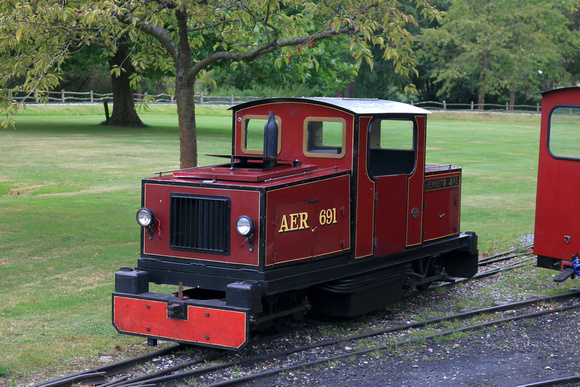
(6, 90, 541, 114)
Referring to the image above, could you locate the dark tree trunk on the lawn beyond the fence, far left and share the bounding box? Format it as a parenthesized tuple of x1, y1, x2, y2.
(105, 45, 145, 127)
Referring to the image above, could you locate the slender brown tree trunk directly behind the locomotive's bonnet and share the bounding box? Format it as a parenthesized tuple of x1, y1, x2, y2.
(175, 72, 197, 168)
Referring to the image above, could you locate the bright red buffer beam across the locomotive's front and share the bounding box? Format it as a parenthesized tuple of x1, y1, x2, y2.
(113, 296, 248, 348)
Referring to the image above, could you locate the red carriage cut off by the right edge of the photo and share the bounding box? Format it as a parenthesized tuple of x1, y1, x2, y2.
(534, 87, 580, 282)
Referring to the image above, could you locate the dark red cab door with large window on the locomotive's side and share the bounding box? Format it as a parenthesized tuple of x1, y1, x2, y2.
(368, 116, 425, 256)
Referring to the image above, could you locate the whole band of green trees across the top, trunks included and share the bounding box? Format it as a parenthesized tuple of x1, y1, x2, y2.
(0, 0, 580, 167)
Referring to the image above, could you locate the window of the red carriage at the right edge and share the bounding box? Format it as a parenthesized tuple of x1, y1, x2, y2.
(548, 107, 580, 159)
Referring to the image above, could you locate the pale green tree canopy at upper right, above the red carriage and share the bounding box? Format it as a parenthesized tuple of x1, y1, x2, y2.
(419, 0, 579, 108)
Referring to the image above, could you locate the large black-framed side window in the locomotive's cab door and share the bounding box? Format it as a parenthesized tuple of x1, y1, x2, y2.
(368, 119, 416, 176)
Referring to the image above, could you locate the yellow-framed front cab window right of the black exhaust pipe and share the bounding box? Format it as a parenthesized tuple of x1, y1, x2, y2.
(304, 117, 346, 158)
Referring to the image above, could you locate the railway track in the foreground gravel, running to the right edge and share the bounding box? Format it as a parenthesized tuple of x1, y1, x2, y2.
(38, 291, 580, 387)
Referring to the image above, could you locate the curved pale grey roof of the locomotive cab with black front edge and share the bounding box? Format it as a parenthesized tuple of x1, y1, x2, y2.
(230, 97, 431, 115)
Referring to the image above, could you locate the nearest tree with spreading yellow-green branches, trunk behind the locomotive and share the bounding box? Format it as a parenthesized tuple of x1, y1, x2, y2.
(0, 0, 438, 167)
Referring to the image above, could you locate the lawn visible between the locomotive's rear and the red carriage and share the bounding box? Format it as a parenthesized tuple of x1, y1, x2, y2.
(427, 113, 540, 252)
